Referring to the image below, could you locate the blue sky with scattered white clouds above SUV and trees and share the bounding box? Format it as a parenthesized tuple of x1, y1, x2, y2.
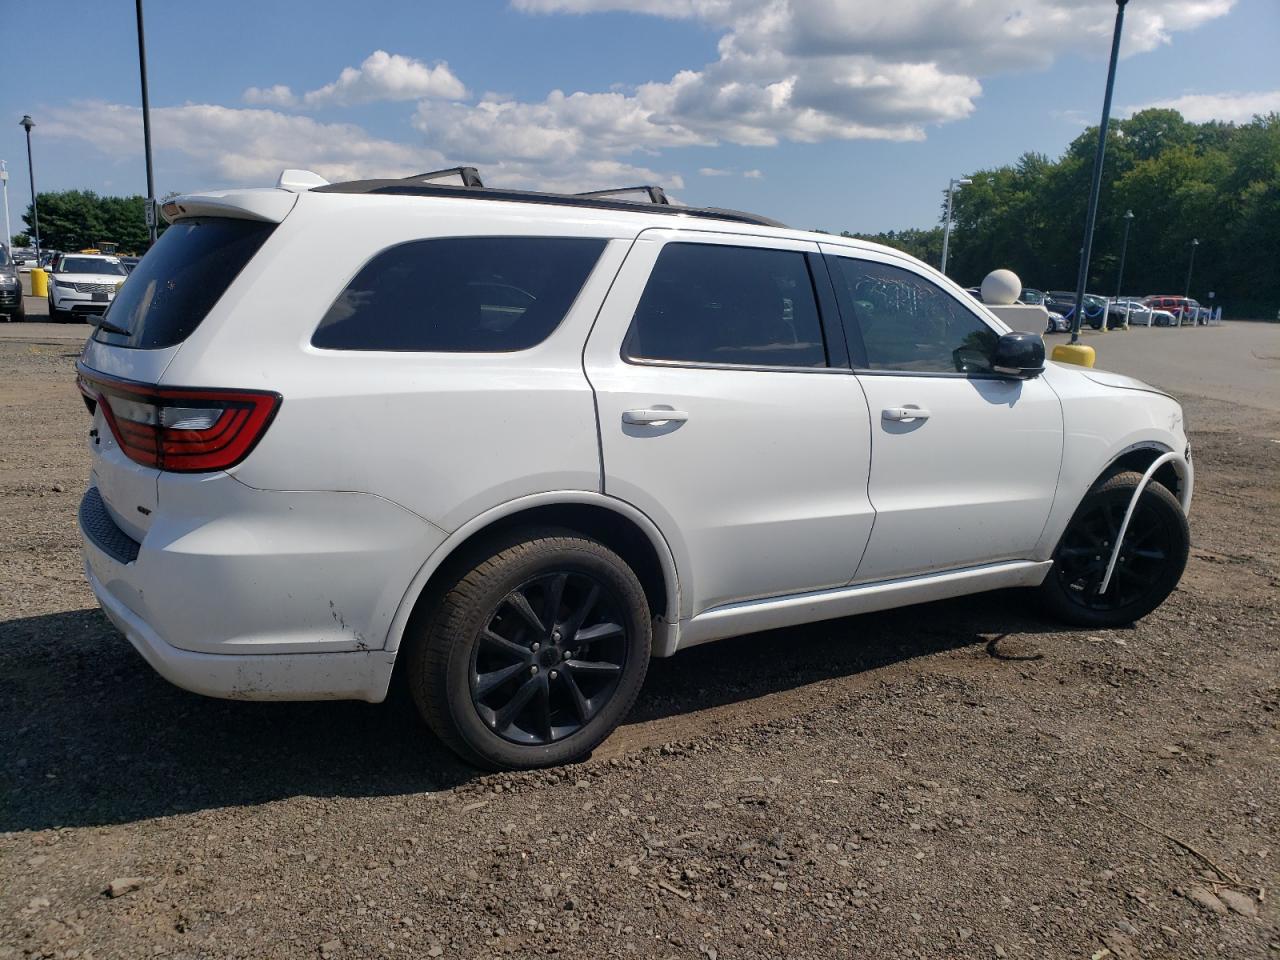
(0, 0, 1280, 232)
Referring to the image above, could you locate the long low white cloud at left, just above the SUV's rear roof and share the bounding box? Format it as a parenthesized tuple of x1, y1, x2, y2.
(41, 101, 443, 189)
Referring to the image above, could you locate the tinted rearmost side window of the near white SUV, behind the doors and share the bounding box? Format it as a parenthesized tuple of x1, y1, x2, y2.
(311, 237, 605, 353)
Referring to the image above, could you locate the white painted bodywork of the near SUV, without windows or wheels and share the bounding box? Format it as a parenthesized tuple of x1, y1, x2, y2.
(83, 184, 1192, 701)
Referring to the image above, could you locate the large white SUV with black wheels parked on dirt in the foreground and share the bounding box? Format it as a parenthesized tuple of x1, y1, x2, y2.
(79, 172, 1192, 768)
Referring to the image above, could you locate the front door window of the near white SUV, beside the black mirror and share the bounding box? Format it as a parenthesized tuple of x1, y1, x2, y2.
(832, 257, 998, 374)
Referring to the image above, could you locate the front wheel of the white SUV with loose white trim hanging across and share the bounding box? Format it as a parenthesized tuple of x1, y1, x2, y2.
(1039, 471, 1190, 627)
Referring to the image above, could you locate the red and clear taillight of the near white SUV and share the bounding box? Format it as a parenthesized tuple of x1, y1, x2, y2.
(76, 365, 280, 474)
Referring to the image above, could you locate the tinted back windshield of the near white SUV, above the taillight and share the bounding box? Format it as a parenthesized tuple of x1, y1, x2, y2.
(96, 218, 275, 349)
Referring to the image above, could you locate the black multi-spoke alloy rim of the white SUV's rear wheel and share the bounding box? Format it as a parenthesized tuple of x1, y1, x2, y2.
(471, 570, 630, 744)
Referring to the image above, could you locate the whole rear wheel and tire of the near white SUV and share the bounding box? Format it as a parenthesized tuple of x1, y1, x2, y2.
(407, 530, 652, 769)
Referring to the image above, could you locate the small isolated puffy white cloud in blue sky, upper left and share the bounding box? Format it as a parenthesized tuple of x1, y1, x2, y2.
(244, 50, 467, 106)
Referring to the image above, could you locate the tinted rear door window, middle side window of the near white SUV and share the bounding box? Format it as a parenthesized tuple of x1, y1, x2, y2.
(623, 243, 827, 366)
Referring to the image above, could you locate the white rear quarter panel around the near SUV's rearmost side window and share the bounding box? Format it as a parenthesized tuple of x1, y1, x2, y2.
(153, 195, 635, 531)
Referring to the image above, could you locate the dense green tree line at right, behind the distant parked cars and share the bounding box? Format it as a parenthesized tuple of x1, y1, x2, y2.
(845, 109, 1280, 317)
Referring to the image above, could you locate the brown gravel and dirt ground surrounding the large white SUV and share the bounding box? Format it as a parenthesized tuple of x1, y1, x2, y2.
(0, 325, 1280, 960)
